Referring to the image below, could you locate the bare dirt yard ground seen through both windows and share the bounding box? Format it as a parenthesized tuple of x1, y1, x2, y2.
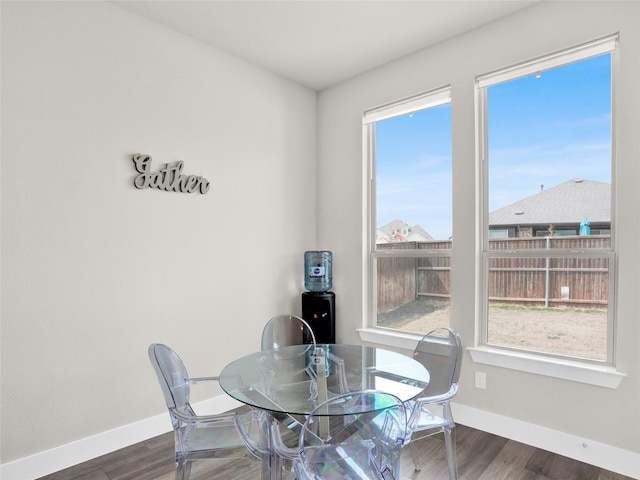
(378, 299, 607, 360)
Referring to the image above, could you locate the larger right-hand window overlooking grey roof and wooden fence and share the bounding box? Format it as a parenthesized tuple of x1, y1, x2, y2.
(476, 37, 617, 364)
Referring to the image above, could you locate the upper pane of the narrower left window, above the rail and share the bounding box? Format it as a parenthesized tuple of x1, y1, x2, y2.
(375, 104, 452, 243)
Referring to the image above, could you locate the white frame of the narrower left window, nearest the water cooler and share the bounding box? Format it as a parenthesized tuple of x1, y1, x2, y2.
(359, 85, 453, 340)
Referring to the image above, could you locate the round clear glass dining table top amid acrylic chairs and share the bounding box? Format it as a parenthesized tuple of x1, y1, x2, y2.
(220, 344, 429, 480)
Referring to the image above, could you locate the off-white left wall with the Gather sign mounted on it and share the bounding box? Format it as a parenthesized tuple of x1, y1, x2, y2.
(0, 1, 316, 463)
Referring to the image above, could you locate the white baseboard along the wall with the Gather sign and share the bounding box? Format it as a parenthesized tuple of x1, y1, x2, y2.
(0, 395, 241, 480)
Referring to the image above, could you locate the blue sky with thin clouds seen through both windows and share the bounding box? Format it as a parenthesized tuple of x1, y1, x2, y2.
(376, 54, 611, 240)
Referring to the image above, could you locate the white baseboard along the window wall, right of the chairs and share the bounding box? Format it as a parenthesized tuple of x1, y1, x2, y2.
(452, 404, 640, 479)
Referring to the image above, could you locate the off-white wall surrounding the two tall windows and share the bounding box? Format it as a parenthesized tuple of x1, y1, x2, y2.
(318, 2, 640, 464)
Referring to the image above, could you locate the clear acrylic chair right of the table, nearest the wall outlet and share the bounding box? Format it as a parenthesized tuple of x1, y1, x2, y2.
(406, 328, 462, 480)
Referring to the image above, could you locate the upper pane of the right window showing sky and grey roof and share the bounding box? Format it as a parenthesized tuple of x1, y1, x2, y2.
(487, 54, 611, 246)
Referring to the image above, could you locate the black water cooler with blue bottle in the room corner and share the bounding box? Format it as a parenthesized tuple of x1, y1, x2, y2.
(302, 250, 336, 343)
